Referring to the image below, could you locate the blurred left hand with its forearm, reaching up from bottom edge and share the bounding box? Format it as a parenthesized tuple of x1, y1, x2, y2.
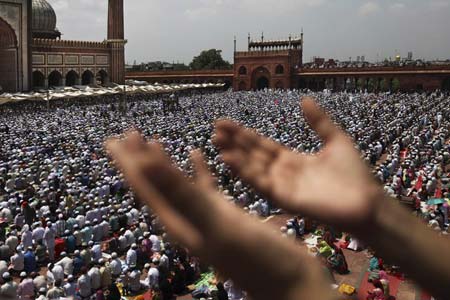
(107, 132, 332, 300)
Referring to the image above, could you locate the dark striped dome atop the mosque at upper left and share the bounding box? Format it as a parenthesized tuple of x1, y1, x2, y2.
(32, 0, 61, 39)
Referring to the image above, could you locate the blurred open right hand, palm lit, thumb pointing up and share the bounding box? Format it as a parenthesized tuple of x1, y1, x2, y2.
(214, 98, 382, 229)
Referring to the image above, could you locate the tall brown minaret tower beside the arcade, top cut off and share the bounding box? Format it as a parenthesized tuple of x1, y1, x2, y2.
(107, 0, 127, 84)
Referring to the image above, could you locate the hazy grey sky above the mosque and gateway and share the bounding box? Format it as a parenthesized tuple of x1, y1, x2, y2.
(48, 0, 450, 63)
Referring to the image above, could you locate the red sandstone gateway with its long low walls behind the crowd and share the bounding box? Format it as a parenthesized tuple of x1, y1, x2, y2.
(126, 32, 450, 92)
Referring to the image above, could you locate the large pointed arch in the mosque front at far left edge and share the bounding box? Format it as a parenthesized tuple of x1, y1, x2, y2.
(0, 18, 18, 92)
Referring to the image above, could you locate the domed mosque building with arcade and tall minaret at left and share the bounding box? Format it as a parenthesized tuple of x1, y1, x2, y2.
(0, 0, 126, 92)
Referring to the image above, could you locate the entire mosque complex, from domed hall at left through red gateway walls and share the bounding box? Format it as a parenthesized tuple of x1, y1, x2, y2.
(0, 0, 450, 92)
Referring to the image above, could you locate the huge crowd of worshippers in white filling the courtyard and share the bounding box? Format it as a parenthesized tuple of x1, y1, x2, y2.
(0, 90, 450, 300)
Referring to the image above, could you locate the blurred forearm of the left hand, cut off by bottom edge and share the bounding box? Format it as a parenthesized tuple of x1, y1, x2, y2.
(208, 208, 334, 300)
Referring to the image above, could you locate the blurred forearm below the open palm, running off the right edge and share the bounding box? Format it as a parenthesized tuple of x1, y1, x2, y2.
(360, 198, 450, 299)
